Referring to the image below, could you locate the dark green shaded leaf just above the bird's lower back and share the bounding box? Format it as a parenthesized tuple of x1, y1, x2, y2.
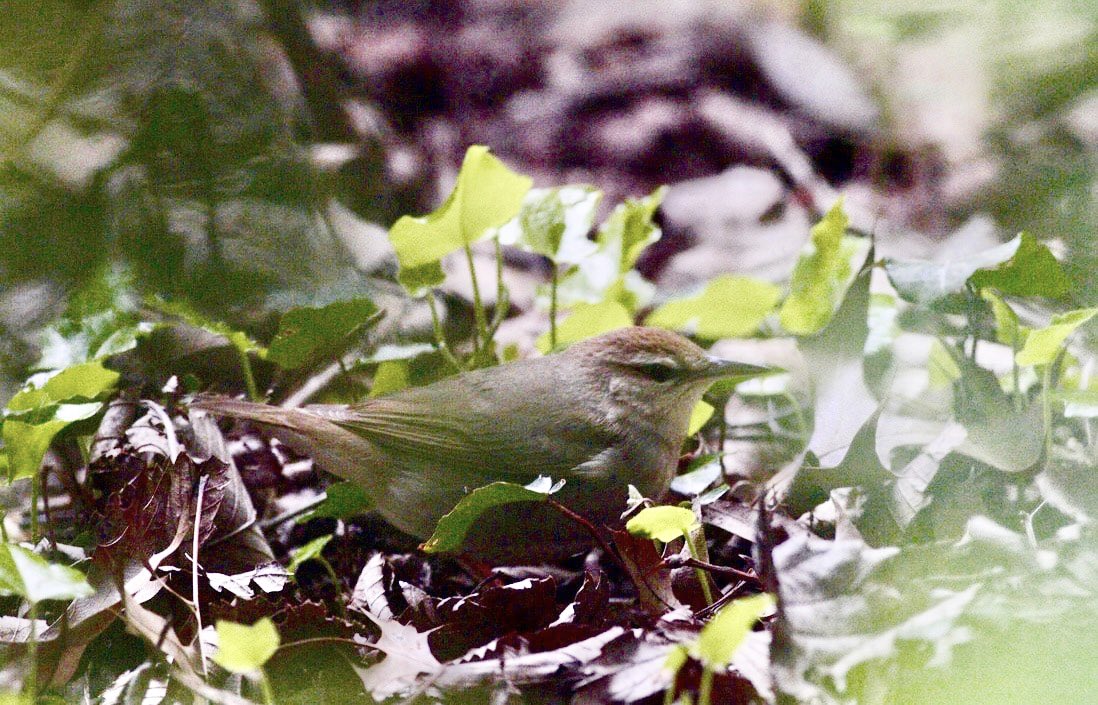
(267, 299, 378, 370)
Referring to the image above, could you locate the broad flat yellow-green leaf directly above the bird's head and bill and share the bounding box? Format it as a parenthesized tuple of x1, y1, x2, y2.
(645, 275, 782, 340)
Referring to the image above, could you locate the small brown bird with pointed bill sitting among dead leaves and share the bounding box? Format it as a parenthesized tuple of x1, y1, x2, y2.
(192, 327, 768, 563)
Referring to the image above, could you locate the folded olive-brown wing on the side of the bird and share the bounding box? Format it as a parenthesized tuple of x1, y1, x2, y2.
(314, 364, 613, 483)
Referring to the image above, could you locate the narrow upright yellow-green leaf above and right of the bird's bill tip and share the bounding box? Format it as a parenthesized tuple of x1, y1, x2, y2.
(778, 199, 869, 335)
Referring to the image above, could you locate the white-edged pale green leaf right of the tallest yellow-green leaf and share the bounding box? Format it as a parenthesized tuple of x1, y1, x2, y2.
(500, 186, 603, 265)
